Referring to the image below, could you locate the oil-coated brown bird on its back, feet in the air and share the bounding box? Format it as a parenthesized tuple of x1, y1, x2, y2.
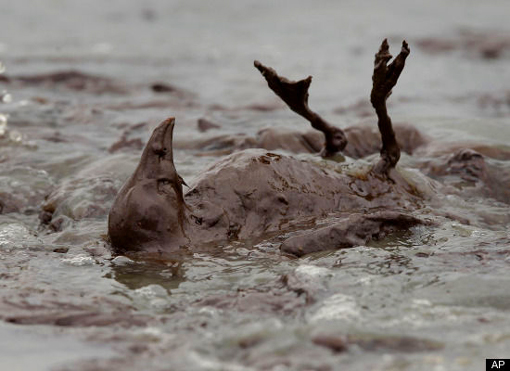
(108, 40, 423, 256)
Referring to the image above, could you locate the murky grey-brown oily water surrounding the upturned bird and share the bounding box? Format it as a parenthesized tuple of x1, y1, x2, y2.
(0, 0, 510, 370)
